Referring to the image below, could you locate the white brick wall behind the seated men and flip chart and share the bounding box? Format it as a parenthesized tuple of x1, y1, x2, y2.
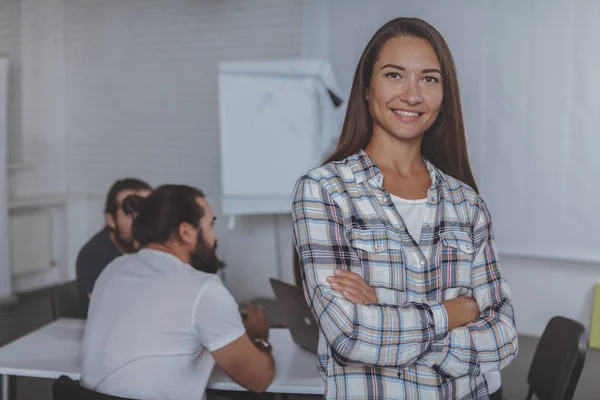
(64, 0, 304, 300)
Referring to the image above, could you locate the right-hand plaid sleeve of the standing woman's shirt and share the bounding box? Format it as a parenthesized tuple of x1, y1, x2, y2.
(419, 199, 518, 378)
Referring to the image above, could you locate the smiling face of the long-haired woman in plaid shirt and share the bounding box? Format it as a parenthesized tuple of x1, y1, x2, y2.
(367, 36, 444, 140)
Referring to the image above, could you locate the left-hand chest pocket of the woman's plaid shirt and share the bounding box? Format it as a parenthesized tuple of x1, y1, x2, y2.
(350, 229, 405, 304)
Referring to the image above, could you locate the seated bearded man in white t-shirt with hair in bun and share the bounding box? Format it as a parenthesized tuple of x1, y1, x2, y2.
(81, 185, 274, 400)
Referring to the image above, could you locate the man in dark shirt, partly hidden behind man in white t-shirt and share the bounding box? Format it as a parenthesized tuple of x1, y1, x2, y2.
(76, 178, 152, 314)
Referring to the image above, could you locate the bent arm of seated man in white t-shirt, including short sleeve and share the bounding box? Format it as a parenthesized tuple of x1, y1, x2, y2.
(193, 281, 275, 393)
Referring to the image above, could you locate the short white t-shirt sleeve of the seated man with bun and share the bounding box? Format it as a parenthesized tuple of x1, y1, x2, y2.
(192, 278, 246, 352)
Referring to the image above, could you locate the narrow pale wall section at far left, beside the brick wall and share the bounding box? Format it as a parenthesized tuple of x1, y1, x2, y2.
(8, 0, 66, 199)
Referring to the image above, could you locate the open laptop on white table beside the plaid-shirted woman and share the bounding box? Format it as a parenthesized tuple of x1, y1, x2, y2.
(269, 278, 319, 354)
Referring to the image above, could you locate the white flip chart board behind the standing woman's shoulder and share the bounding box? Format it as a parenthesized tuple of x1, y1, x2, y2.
(219, 59, 341, 215)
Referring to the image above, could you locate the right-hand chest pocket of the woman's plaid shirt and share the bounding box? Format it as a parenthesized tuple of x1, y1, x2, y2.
(438, 231, 475, 292)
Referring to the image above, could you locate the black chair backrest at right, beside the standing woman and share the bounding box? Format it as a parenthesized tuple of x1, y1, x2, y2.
(527, 317, 588, 400)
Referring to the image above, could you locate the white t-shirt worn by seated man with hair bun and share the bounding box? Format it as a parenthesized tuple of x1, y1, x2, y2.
(81, 249, 245, 400)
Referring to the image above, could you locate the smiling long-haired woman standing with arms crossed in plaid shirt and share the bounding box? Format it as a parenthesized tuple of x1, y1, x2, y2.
(292, 18, 518, 399)
